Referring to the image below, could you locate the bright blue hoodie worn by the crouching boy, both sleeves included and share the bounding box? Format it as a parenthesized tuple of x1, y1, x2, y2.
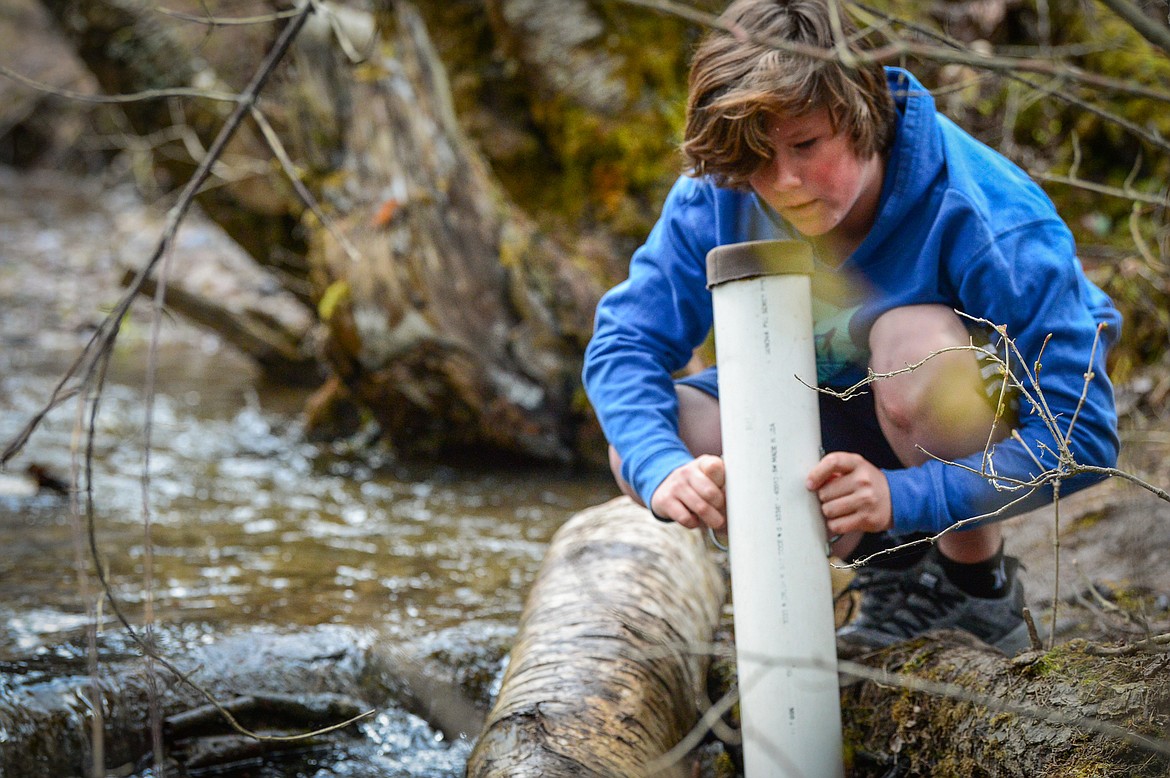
(584, 68, 1121, 532)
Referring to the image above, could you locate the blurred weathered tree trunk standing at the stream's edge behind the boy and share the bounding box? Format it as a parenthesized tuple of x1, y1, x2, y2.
(301, 4, 600, 460)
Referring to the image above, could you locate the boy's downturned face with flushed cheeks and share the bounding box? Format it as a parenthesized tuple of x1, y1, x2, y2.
(748, 109, 883, 252)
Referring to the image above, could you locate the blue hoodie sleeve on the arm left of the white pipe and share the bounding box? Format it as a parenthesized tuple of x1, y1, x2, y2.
(583, 177, 716, 504)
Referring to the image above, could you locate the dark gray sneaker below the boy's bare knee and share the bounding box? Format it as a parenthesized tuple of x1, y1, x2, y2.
(837, 551, 1028, 656)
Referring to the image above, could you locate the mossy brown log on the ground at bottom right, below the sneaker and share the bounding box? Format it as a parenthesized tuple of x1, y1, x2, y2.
(841, 633, 1170, 778)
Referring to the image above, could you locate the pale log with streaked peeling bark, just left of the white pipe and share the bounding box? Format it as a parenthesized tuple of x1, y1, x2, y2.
(468, 498, 724, 778)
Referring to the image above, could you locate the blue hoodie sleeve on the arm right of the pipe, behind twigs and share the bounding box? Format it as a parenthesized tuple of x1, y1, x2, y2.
(886, 220, 1121, 532)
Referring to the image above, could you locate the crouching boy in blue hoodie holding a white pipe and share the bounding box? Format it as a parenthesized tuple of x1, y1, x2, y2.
(584, 0, 1121, 654)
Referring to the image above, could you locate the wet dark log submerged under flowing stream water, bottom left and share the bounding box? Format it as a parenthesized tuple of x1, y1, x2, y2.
(0, 626, 503, 777)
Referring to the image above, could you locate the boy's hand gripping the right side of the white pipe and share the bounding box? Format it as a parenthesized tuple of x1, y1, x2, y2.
(805, 452, 894, 536)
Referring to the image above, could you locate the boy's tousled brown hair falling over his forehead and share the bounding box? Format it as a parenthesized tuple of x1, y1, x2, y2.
(682, 0, 895, 188)
